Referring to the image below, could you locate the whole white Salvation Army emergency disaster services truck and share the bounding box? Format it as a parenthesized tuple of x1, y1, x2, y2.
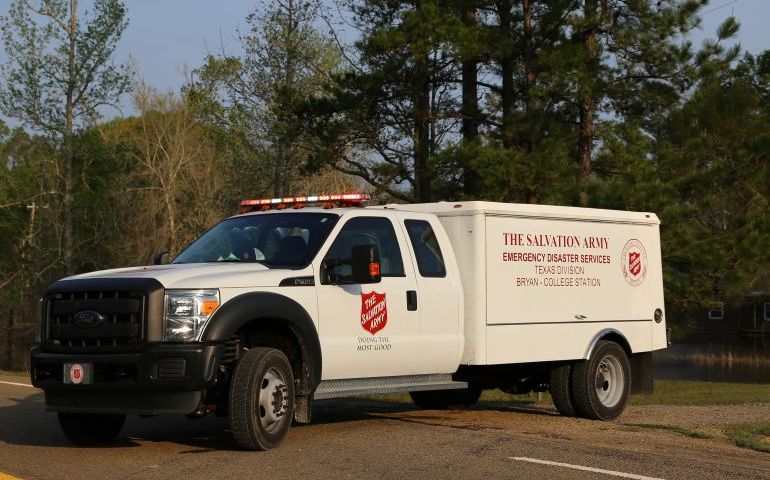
(31, 194, 667, 450)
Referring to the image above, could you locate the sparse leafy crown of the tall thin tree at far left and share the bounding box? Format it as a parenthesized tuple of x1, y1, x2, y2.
(0, 0, 131, 138)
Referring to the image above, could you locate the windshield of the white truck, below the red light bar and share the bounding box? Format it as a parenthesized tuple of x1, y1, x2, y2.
(172, 213, 339, 268)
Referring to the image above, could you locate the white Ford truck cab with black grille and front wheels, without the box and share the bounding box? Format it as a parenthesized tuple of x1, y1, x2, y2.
(32, 194, 463, 448)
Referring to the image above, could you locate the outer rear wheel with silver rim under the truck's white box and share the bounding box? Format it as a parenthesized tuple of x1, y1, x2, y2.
(572, 340, 631, 420)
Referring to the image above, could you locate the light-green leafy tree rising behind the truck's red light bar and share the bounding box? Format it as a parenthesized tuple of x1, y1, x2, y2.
(185, 0, 340, 196)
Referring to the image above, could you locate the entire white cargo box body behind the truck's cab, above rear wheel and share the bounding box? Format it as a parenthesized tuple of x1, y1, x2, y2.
(390, 202, 666, 365)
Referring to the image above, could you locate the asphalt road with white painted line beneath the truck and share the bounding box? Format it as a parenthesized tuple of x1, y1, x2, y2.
(0, 377, 770, 480)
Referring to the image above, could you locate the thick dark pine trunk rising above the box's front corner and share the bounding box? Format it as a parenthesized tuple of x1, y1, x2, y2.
(460, 0, 479, 198)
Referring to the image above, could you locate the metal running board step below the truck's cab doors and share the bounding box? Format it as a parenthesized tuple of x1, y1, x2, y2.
(313, 374, 468, 400)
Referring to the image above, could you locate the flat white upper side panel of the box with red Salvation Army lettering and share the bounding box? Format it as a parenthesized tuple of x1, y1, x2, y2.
(485, 215, 663, 325)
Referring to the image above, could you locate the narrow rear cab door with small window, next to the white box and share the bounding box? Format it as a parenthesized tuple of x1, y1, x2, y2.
(397, 212, 463, 373)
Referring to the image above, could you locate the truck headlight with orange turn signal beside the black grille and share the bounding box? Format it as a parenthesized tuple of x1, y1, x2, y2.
(163, 290, 219, 342)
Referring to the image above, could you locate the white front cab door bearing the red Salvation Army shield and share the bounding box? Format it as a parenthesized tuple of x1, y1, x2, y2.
(316, 212, 422, 380)
